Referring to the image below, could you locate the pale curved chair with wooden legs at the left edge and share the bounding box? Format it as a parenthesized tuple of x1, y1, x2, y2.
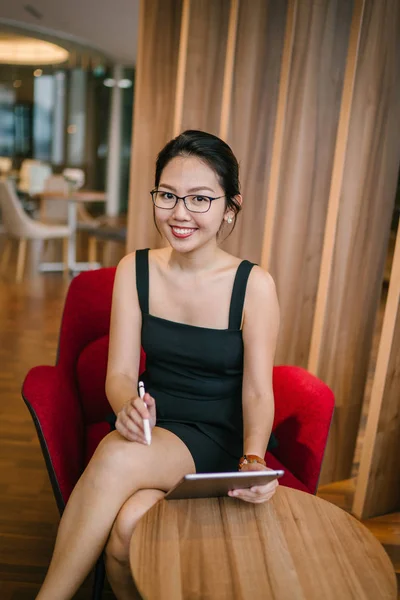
(0, 181, 70, 282)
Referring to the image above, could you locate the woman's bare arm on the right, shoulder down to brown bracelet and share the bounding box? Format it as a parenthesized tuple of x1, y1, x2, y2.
(242, 266, 280, 457)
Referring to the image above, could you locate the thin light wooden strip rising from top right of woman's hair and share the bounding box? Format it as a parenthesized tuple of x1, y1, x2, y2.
(219, 0, 239, 140)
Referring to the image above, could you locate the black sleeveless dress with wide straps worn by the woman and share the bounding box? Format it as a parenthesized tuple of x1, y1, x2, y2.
(108, 249, 274, 473)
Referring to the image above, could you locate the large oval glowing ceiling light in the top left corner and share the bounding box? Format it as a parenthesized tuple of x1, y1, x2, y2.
(0, 33, 69, 65)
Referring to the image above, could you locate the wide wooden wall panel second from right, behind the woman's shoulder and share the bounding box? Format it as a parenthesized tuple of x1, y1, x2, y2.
(264, 0, 352, 367)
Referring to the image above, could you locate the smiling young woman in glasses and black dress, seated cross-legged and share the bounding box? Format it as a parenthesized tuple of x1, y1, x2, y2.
(38, 131, 279, 600)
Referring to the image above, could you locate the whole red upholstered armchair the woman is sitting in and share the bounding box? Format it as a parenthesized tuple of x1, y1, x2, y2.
(22, 268, 334, 598)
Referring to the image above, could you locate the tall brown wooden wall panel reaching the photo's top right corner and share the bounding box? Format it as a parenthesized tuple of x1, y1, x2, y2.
(317, 0, 400, 483)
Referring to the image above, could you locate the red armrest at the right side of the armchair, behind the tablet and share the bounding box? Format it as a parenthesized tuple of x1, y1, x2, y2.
(272, 366, 335, 494)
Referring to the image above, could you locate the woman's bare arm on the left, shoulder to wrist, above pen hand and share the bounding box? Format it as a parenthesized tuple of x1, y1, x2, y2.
(106, 253, 142, 414)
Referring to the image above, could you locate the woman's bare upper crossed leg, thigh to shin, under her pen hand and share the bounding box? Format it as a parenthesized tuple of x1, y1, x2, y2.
(37, 427, 195, 600)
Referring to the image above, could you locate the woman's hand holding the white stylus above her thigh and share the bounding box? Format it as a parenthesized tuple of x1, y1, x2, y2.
(115, 393, 156, 445)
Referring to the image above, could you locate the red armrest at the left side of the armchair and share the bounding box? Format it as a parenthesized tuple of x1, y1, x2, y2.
(22, 366, 84, 512)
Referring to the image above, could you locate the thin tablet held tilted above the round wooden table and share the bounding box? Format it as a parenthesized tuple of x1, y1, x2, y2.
(164, 470, 284, 500)
